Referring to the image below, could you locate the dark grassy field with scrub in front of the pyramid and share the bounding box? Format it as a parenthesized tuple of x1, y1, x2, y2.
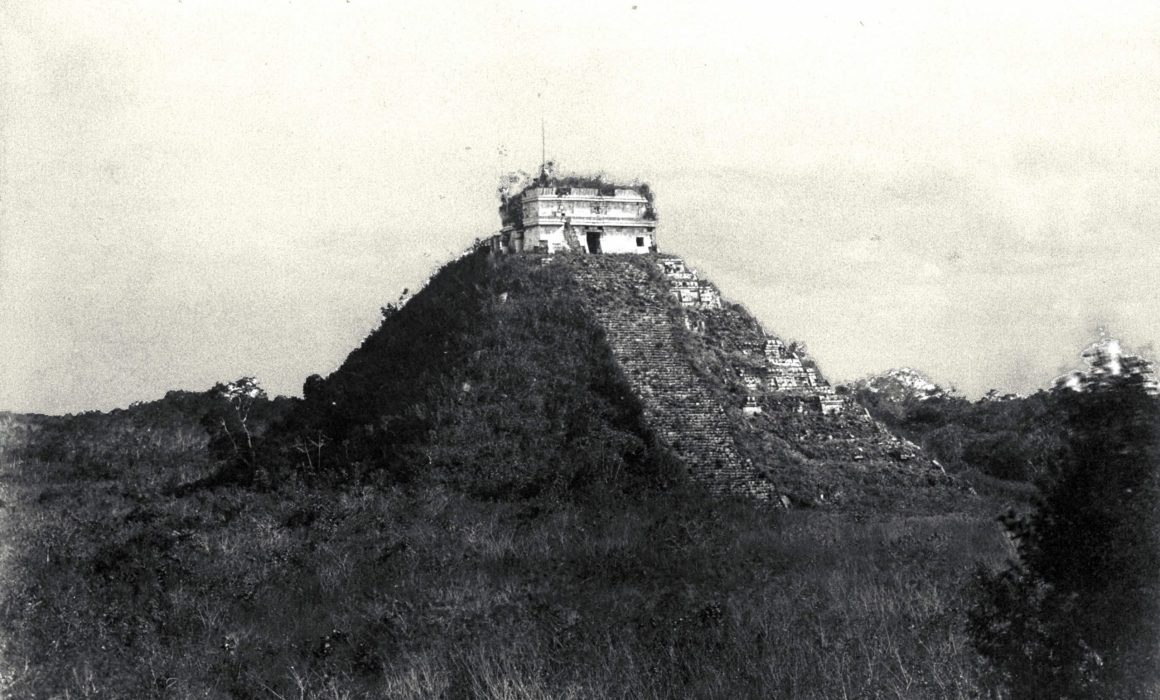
(0, 431, 1009, 699)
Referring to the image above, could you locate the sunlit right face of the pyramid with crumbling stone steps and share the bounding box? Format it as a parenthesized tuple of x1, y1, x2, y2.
(552, 254, 954, 507)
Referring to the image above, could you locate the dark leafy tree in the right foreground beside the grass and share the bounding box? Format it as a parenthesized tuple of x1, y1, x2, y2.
(969, 373, 1160, 699)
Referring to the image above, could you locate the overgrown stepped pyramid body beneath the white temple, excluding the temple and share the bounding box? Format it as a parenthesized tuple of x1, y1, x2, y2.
(252, 246, 966, 511)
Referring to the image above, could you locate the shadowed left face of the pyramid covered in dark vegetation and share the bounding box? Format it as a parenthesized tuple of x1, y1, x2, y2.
(264, 251, 677, 497)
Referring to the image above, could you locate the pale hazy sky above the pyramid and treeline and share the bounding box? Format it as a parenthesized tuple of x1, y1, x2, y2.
(0, 0, 1160, 412)
